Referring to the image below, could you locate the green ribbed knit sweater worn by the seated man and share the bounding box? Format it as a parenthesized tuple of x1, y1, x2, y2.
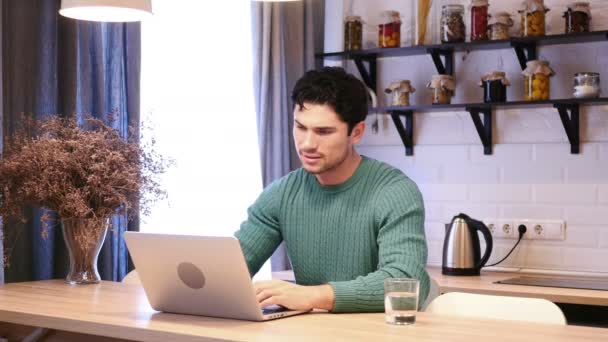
(235, 157, 429, 312)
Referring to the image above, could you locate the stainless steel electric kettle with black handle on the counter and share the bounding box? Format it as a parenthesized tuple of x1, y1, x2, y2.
(441, 213, 492, 275)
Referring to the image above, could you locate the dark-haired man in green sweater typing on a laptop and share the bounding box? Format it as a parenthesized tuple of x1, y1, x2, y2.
(235, 67, 429, 312)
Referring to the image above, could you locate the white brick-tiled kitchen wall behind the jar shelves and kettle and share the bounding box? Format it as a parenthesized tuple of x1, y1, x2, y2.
(326, 0, 608, 272)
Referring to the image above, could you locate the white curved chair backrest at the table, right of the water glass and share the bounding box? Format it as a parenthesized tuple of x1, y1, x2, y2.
(426, 292, 566, 325)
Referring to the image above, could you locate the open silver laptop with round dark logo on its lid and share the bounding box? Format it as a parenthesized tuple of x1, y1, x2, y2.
(124, 232, 307, 321)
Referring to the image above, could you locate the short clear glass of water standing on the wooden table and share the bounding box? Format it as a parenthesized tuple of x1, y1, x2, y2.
(384, 278, 420, 325)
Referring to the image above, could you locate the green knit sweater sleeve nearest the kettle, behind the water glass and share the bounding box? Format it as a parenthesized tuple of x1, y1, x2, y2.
(329, 178, 430, 313)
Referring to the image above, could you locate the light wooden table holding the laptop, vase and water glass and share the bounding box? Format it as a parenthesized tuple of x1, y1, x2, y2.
(0, 280, 608, 342)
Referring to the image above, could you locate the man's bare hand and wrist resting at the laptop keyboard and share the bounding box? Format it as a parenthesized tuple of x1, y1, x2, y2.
(253, 280, 334, 311)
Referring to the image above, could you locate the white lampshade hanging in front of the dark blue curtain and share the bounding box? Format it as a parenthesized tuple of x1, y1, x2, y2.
(59, 0, 152, 22)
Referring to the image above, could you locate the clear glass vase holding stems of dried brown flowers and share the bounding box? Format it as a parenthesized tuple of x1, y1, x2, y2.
(61, 218, 109, 285)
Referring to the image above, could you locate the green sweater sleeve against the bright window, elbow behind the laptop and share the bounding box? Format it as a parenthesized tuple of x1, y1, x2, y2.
(234, 181, 283, 276)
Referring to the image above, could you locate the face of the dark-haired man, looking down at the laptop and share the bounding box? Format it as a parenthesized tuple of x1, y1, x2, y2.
(293, 103, 362, 175)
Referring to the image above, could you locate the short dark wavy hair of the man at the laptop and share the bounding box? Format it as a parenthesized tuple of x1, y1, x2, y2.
(291, 67, 368, 135)
